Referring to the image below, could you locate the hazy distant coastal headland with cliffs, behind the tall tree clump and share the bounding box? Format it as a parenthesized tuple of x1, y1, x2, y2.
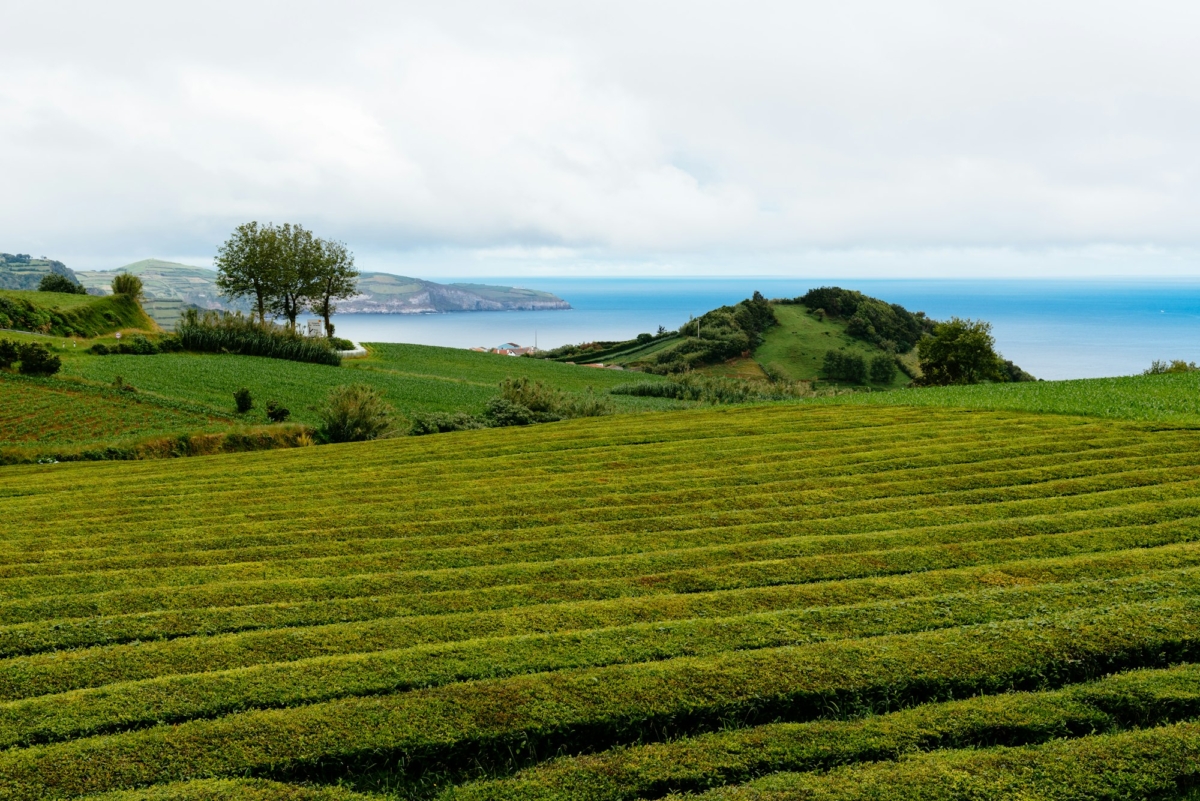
(76, 259, 571, 314)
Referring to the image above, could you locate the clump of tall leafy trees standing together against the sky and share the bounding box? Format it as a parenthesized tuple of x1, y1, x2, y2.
(216, 222, 359, 336)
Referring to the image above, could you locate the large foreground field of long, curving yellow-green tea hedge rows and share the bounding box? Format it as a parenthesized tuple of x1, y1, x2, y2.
(0, 405, 1200, 801)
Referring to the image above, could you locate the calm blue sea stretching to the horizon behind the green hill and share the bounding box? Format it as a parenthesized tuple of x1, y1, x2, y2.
(316, 277, 1200, 379)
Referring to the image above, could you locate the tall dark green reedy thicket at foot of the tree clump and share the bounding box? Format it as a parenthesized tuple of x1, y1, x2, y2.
(175, 311, 342, 367)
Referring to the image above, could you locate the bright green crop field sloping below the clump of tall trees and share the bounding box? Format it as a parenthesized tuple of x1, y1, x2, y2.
(62, 344, 680, 424)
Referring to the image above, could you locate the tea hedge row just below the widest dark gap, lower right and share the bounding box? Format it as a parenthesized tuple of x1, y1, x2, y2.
(439, 664, 1200, 801)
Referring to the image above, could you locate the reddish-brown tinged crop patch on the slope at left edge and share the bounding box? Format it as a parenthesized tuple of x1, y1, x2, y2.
(0, 374, 230, 448)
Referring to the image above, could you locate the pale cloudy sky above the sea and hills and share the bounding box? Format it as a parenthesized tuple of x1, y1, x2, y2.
(0, 0, 1200, 279)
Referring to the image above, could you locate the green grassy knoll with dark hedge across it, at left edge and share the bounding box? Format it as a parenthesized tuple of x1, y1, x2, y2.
(0, 291, 154, 337)
